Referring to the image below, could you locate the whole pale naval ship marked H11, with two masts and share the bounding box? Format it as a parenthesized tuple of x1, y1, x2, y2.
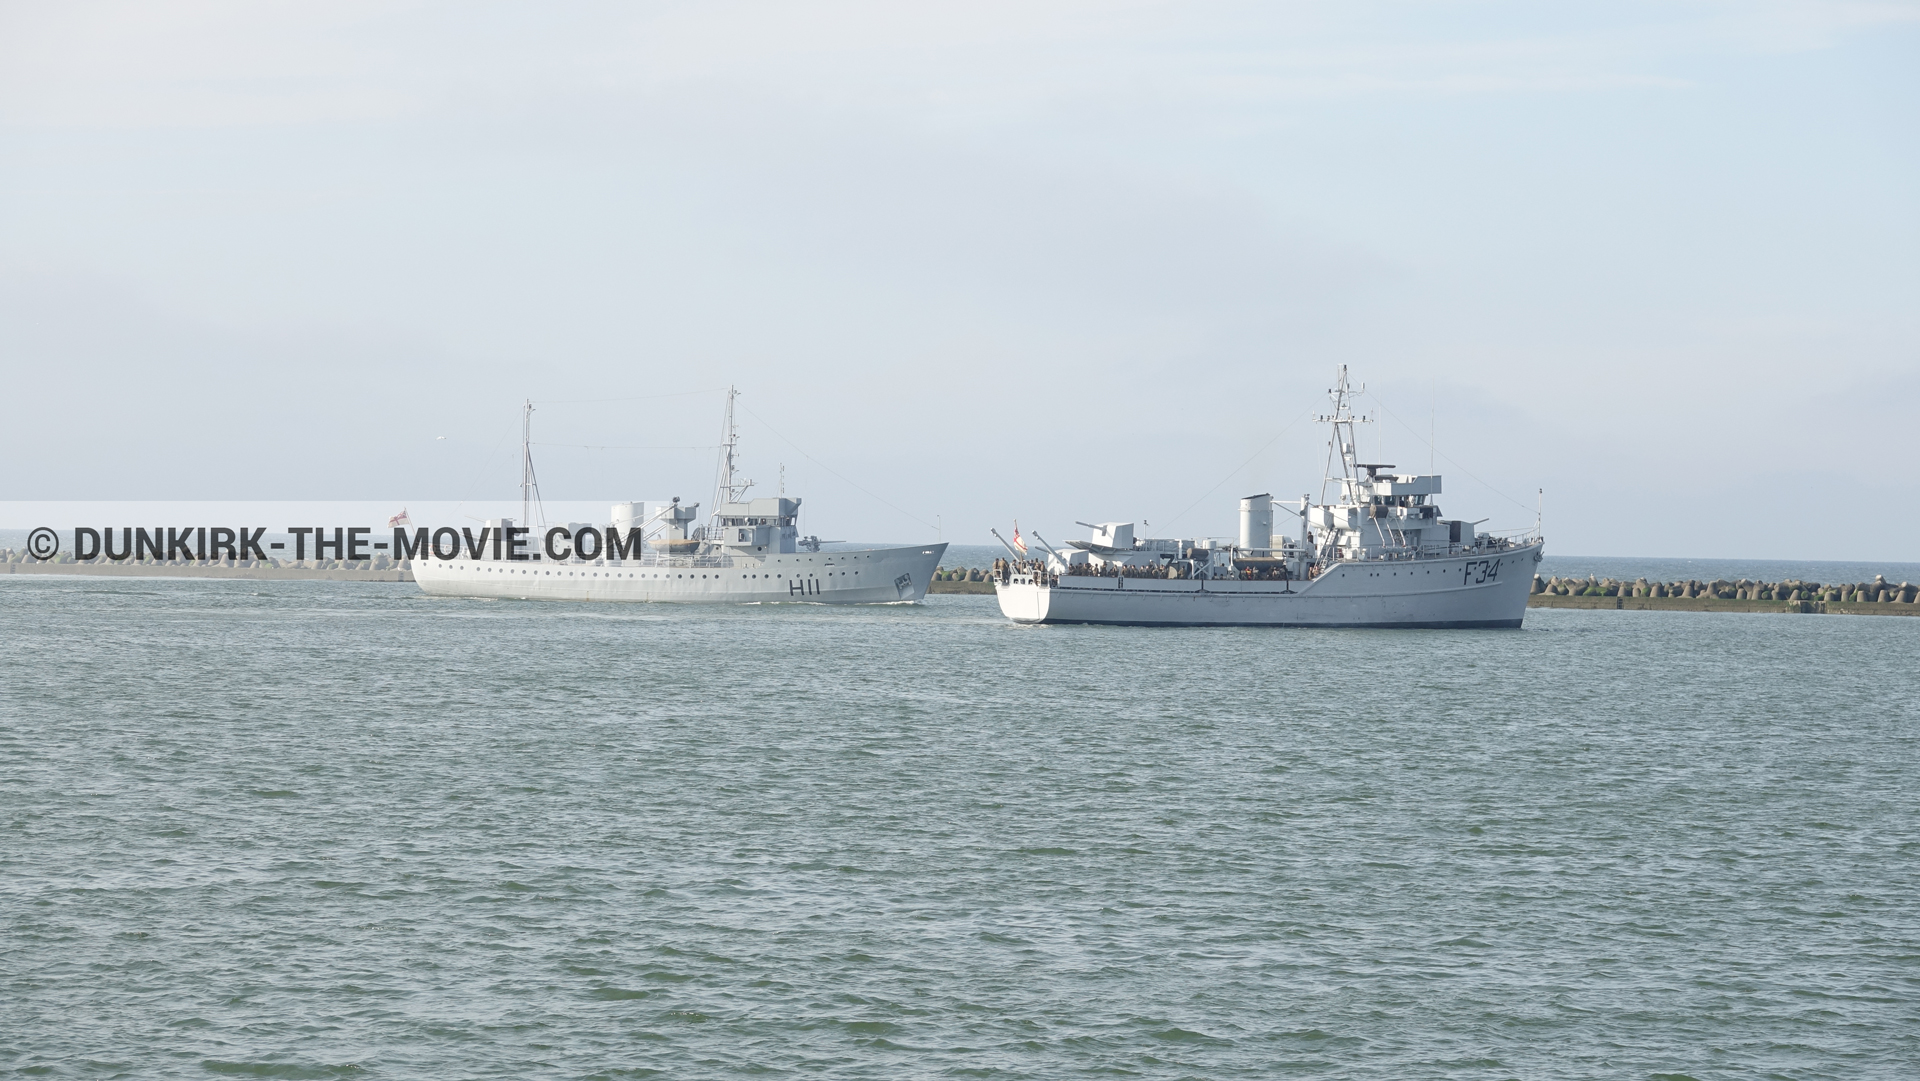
(413, 390, 947, 605)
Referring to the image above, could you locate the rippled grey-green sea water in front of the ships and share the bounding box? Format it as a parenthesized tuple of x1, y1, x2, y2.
(0, 576, 1920, 1081)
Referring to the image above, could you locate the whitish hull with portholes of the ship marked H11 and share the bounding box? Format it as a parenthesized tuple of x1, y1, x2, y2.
(413, 543, 947, 605)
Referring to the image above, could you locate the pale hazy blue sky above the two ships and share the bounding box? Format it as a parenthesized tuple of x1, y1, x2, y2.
(0, 0, 1920, 561)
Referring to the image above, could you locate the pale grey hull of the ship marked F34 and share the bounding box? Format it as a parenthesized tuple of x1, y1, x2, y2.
(995, 543, 1542, 628)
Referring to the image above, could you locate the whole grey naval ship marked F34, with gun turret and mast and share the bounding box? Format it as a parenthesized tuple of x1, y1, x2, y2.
(995, 365, 1544, 628)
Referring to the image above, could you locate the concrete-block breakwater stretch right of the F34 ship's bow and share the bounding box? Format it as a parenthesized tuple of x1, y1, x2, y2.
(1528, 574, 1920, 616)
